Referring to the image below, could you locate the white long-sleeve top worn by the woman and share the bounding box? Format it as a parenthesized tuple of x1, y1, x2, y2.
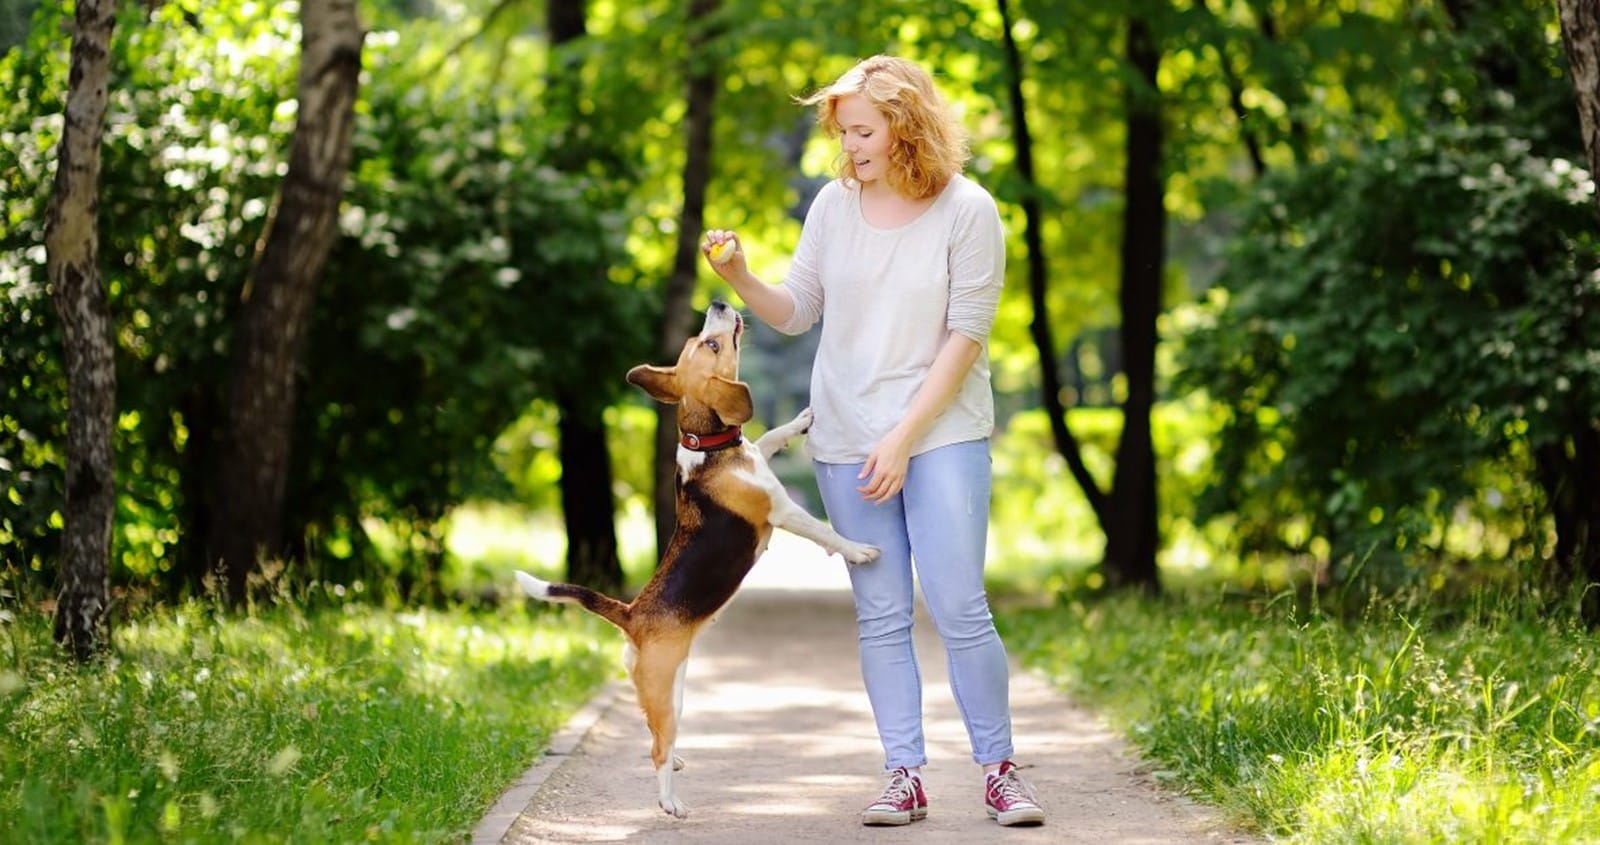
(773, 174, 1005, 464)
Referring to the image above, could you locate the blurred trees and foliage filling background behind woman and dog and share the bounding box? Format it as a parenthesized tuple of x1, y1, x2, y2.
(0, 0, 1600, 640)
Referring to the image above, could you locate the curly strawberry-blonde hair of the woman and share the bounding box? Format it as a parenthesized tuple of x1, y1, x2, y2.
(800, 56, 970, 200)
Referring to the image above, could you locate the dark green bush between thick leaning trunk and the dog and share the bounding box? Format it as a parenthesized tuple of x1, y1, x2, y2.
(298, 24, 653, 582)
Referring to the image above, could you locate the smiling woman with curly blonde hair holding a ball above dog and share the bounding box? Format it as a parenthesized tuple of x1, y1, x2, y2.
(702, 56, 1045, 826)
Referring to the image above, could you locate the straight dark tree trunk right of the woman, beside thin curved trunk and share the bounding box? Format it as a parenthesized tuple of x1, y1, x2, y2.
(1104, 18, 1166, 592)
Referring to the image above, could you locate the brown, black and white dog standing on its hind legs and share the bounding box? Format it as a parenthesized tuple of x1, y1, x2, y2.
(517, 302, 878, 818)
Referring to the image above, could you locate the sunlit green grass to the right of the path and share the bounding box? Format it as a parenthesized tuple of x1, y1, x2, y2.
(1000, 595, 1600, 845)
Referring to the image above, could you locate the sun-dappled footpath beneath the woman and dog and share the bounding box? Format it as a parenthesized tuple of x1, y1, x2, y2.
(472, 536, 1258, 845)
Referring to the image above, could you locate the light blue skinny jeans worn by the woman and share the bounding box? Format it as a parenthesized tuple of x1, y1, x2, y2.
(816, 440, 1013, 768)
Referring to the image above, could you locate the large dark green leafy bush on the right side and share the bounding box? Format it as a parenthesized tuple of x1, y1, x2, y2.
(1179, 126, 1600, 575)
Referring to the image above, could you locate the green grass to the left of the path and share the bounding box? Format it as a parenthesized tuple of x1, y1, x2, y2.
(0, 603, 621, 843)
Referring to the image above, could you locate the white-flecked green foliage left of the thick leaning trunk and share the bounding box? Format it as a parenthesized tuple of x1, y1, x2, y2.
(0, 3, 316, 588)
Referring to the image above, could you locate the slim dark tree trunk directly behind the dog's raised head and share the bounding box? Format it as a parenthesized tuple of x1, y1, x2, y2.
(654, 0, 720, 559)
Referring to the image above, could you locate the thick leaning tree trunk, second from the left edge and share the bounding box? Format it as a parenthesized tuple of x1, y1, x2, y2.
(208, 0, 363, 603)
